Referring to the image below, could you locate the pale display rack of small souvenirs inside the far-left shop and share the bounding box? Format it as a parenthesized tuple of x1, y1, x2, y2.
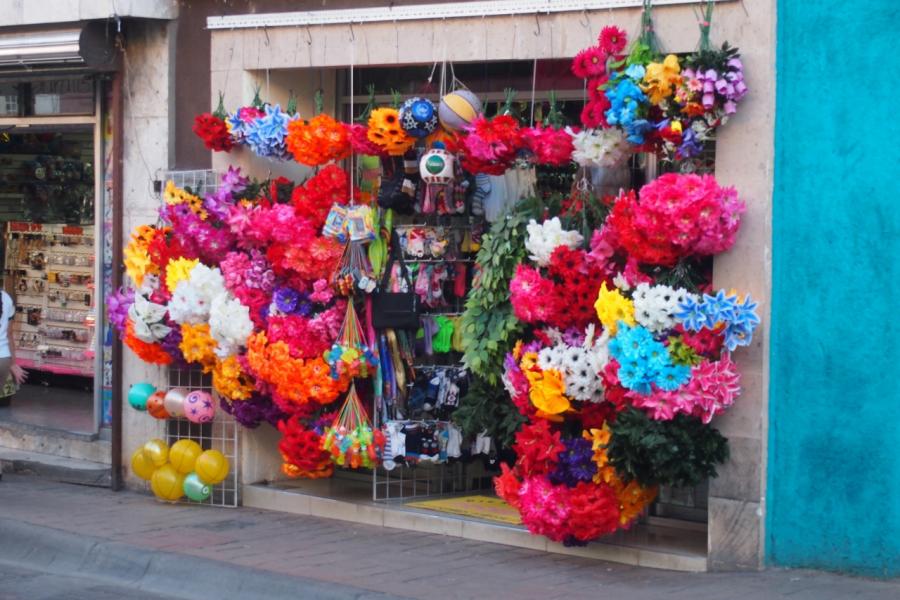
(4, 222, 96, 377)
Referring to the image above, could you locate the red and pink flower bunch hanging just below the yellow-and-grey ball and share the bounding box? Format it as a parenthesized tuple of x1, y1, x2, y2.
(459, 115, 523, 175)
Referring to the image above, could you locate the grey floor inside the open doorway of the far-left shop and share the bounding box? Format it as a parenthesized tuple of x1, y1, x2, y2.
(0, 382, 94, 433)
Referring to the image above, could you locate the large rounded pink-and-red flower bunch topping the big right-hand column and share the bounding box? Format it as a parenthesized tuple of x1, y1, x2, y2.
(607, 173, 744, 266)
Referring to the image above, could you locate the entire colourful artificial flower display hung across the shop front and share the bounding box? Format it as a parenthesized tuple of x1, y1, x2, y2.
(114, 1, 759, 544)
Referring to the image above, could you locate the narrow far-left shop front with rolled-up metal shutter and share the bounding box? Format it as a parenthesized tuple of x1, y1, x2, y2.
(0, 24, 115, 464)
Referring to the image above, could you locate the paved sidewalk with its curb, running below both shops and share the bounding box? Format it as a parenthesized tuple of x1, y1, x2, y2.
(0, 475, 900, 600)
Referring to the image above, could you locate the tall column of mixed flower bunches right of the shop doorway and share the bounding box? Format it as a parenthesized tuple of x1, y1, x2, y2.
(495, 168, 759, 544)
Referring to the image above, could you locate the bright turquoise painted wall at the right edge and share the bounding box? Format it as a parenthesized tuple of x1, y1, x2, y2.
(766, 0, 900, 576)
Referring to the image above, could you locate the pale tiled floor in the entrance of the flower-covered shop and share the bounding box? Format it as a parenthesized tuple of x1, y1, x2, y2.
(253, 477, 707, 568)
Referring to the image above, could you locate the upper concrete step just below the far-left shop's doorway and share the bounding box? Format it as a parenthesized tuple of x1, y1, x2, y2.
(0, 420, 112, 466)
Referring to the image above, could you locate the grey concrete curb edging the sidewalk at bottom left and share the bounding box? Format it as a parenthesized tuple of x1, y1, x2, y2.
(0, 517, 398, 600)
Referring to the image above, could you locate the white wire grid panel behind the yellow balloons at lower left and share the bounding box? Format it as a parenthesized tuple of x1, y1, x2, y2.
(165, 368, 240, 508)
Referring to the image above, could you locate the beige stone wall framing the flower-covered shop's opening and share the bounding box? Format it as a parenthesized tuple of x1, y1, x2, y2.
(200, 0, 775, 569)
